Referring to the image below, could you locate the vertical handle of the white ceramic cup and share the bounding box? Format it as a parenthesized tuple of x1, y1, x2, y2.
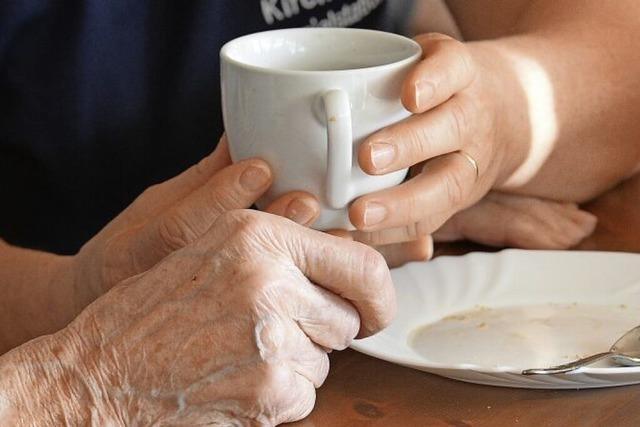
(322, 89, 353, 209)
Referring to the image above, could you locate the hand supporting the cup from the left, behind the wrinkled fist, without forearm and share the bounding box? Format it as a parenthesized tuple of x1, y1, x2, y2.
(73, 137, 319, 300)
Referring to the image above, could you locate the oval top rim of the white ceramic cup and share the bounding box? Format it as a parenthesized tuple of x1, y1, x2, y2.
(220, 27, 422, 76)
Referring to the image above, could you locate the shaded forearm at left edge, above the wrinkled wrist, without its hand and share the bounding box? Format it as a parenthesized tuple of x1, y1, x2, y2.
(0, 240, 89, 354)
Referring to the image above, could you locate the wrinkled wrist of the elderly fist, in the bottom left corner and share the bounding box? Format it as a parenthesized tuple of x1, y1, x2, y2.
(0, 330, 126, 427)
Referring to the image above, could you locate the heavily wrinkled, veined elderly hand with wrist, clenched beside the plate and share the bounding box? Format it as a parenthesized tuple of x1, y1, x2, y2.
(0, 210, 395, 425)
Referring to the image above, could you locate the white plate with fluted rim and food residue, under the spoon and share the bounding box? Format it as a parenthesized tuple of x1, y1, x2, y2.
(352, 250, 640, 389)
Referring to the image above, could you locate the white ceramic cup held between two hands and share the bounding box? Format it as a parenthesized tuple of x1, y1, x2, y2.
(220, 28, 421, 230)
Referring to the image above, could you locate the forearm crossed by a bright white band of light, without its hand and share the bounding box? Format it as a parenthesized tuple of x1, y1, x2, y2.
(470, 0, 640, 202)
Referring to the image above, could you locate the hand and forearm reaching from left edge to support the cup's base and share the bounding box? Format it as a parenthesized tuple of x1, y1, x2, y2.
(0, 138, 336, 354)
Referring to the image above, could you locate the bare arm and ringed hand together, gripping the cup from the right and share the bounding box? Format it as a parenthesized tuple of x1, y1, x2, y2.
(342, 0, 640, 247)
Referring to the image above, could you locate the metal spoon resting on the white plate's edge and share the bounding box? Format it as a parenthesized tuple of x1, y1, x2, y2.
(522, 326, 640, 375)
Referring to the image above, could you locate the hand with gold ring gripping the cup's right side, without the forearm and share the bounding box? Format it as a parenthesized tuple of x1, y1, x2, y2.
(349, 34, 513, 244)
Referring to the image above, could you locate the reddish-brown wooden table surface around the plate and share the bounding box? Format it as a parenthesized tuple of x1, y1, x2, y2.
(291, 176, 640, 427)
